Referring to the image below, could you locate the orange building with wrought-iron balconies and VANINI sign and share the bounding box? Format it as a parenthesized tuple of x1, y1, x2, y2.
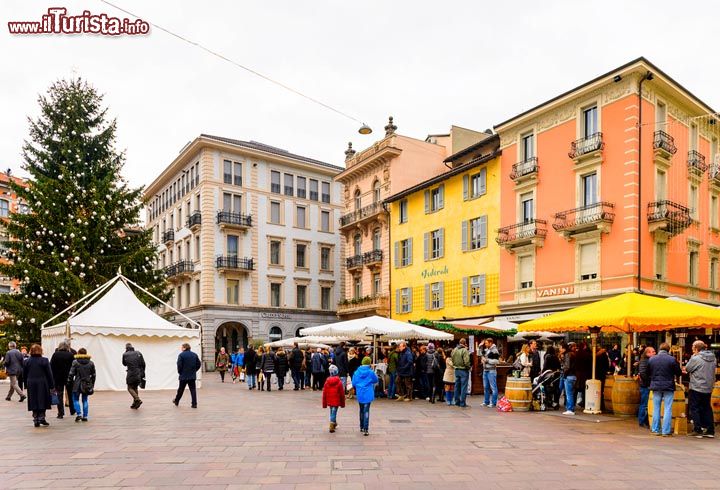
(495, 58, 720, 320)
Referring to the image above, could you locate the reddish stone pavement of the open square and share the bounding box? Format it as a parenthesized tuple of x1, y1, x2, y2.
(0, 375, 720, 490)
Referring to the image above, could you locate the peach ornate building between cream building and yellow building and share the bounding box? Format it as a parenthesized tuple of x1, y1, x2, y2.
(335, 118, 482, 319)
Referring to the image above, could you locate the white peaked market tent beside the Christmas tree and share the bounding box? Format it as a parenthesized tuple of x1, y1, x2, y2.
(42, 274, 201, 391)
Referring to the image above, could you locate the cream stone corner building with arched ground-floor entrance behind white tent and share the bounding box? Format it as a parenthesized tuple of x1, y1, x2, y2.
(145, 135, 342, 369)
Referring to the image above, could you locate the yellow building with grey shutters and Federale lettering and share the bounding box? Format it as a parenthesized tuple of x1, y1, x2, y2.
(386, 135, 501, 321)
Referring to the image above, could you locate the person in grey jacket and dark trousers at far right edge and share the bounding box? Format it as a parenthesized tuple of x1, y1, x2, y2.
(683, 340, 717, 439)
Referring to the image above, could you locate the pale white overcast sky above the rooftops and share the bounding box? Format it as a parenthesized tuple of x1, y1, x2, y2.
(0, 0, 720, 189)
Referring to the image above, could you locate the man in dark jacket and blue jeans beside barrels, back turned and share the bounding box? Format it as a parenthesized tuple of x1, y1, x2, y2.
(648, 342, 682, 437)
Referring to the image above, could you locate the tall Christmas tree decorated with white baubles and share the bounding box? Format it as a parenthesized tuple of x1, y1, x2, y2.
(0, 79, 167, 341)
